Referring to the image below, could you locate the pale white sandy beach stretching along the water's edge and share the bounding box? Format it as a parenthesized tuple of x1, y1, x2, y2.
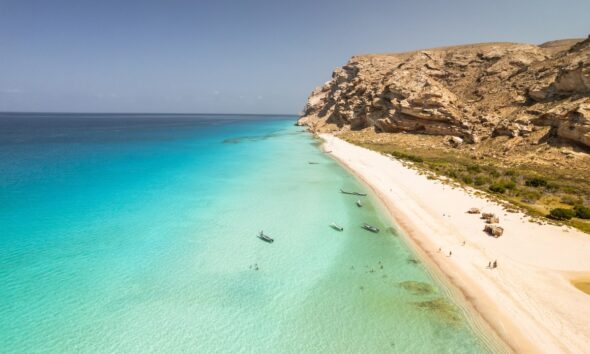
(321, 134, 590, 353)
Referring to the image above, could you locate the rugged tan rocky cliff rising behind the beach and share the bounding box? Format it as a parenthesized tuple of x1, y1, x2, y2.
(298, 37, 590, 147)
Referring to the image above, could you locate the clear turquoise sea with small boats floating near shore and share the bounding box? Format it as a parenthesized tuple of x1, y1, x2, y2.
(0, 114, 490, 353)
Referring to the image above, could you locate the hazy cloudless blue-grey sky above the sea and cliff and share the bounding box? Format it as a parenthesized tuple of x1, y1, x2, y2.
(0, 0, 590, 113)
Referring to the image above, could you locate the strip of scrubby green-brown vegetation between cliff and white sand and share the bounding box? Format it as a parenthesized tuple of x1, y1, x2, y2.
(343, 132, 590, 233)
